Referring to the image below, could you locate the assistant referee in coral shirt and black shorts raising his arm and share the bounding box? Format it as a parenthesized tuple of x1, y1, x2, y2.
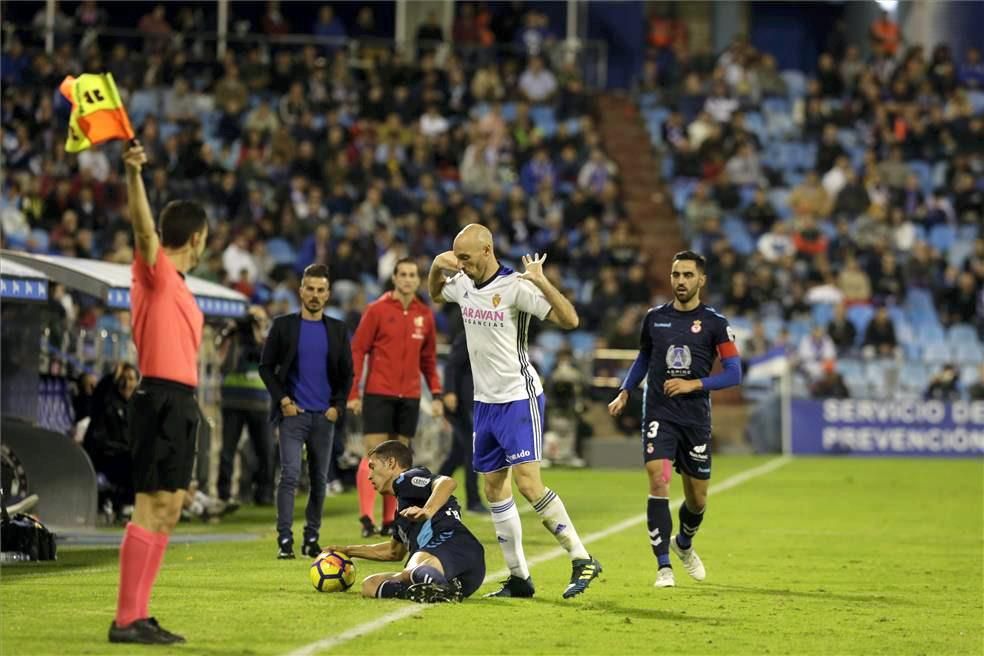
(109, 142, 208, 644)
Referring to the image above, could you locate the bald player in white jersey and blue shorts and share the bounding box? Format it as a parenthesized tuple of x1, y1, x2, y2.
(427, 223, 601, 599)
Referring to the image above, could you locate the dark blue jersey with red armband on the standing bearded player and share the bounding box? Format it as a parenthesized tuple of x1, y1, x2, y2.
(622, 303, 741, 428)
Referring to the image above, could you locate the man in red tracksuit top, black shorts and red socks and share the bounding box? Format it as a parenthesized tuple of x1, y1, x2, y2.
(348, 258, 444, 537)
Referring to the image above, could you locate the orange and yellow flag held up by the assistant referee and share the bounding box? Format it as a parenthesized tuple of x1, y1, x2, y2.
(58, 73, 134, 153)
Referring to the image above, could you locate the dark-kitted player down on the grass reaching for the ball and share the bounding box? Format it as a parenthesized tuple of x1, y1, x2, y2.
(328, 440, 485, 603)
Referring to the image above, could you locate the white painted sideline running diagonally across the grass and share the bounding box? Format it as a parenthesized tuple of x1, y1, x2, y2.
(285, 456, 792, 656)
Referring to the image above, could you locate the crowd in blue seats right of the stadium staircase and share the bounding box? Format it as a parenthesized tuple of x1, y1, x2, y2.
(638, 11, 984, 400)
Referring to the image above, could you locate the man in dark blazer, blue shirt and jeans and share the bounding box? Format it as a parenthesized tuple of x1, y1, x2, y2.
(260, 264, 352, 559)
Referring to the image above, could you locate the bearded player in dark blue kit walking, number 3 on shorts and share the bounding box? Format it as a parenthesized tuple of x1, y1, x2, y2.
(608, 251, 741, 588)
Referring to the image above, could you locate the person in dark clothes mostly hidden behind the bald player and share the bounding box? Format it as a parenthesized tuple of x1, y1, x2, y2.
(439, 330, 488, 513)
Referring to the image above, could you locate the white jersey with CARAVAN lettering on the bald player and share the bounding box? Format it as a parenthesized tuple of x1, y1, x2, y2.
(441, 266, 550, 403)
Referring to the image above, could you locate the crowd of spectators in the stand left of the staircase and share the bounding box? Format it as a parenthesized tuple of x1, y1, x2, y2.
(0, 2, 640, 348)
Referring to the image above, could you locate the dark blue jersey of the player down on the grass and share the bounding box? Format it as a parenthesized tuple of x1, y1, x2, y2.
(393, 467, 477, 555)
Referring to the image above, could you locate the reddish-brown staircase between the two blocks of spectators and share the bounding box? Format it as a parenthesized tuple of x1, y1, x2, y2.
(598, 94, 684, 298)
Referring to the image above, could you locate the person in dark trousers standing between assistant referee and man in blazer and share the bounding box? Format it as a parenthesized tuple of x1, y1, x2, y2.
(217, 306, 274, 506)
